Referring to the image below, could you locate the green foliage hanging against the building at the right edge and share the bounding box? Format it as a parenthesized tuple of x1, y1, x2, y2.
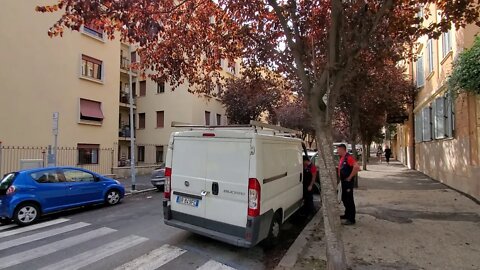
(448, 36, 480, 95)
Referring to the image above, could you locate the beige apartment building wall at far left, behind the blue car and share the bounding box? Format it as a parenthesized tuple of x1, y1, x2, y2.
(0, 0, 120, 174)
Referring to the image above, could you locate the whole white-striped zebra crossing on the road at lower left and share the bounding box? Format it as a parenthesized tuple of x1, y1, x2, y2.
(0, 218, 235, 270)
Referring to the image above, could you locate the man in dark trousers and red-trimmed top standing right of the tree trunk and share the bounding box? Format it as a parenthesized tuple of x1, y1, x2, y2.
(337, 144, 360, 225)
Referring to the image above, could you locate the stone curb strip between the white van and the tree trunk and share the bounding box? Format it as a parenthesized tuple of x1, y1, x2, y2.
(275, 208, 323, 270)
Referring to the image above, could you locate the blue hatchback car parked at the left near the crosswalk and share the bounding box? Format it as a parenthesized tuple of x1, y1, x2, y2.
(0, 167, 125, 225)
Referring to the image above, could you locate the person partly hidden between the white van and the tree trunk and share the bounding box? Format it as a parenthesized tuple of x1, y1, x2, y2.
(303, 156, 317, 217)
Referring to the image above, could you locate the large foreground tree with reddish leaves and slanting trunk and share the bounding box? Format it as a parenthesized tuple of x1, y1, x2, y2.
(37, 0, 480, 269)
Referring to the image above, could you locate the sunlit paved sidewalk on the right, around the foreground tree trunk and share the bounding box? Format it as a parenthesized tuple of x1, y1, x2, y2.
(279, 162, 480, 269)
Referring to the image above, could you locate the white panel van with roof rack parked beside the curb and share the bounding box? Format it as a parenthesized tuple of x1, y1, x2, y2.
(163, 122, 303, 247)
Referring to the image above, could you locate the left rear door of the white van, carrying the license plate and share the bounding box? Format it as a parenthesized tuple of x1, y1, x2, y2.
(171, 137, 207, 218)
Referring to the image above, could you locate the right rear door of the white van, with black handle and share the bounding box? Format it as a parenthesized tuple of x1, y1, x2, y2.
(205, 138, 251, 227)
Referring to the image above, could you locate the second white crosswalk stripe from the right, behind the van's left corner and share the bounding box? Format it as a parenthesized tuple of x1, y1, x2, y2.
(115, 245, 187, 270)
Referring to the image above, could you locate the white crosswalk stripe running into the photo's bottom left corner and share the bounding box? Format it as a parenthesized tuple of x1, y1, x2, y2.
(0, 227, 116, 269)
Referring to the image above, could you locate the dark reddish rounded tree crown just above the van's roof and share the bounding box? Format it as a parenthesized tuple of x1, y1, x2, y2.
(220, 69, 284, 124)
